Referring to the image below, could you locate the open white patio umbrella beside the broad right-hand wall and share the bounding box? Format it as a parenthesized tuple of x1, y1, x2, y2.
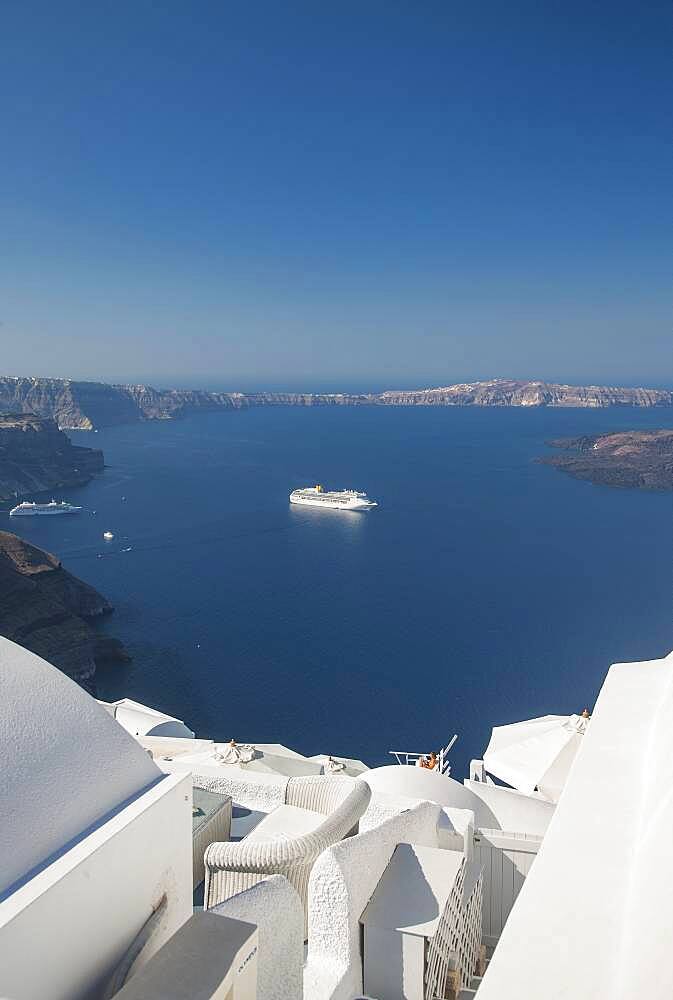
(484, 715, 589, 802)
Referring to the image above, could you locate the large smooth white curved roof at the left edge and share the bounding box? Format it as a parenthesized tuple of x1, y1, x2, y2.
(0, 636, 162, 896)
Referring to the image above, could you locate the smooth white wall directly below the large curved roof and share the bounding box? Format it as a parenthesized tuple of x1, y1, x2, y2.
(0, 772, 192, 1000)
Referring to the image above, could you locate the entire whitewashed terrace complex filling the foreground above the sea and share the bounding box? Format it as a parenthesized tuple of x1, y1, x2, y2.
(0, 639, 673, 1000)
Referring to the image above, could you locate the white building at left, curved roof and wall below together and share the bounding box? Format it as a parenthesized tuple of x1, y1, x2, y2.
(0, 638, 192, 1000)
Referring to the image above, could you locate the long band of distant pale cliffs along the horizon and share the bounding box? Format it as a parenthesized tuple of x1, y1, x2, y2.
(0, 376, 673, 430)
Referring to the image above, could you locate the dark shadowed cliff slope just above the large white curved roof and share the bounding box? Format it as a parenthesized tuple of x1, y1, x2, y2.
(0, 531, 129, 689)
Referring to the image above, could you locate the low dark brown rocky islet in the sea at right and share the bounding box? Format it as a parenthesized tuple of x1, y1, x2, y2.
(540, 430, 673, 490)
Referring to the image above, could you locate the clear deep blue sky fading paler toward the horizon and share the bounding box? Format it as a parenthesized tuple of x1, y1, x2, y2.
(0, 0, 673, 388)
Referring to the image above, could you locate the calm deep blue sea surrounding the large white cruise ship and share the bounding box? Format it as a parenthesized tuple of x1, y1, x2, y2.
(2, 409, 673, 774)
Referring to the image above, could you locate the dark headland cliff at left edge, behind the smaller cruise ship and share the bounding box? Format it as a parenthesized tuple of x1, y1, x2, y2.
(0, 413, 103, 500)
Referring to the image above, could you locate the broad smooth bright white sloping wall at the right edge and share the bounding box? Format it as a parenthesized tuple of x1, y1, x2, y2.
(479, 655, 673, 1000)
